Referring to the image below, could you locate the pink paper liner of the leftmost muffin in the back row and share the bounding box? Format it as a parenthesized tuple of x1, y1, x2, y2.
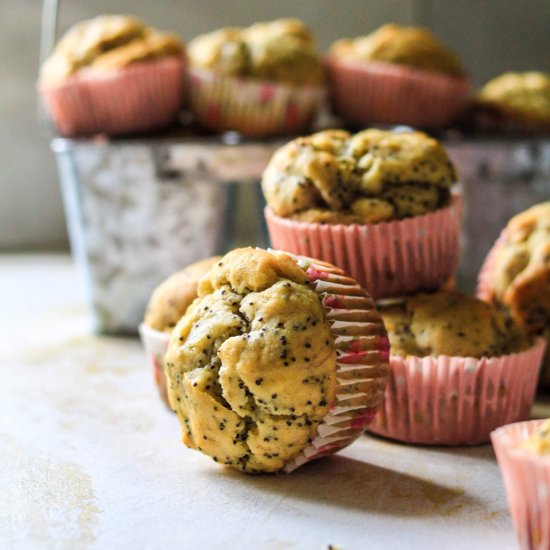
(38, 57, 185, 136)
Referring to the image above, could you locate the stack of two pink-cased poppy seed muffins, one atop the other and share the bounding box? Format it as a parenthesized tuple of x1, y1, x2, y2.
(262, 130, 548, 445)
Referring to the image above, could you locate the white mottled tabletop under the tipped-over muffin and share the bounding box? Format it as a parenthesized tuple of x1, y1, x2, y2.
(0, 256, 548, 550)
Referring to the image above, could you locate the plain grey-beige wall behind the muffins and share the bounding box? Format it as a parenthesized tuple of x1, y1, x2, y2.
(0, 0, 550, 250)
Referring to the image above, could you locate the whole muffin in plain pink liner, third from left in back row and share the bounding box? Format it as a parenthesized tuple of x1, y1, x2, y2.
(327, 24, 470, 128)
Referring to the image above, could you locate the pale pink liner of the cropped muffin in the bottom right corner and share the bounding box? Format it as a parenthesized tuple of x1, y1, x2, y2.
(491, 420, 550, 550)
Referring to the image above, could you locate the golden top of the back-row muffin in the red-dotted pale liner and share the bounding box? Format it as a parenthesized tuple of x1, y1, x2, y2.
(189, 19, 323, 85)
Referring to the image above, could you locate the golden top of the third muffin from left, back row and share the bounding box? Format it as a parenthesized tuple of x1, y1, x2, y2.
(329, 24, 464, 76)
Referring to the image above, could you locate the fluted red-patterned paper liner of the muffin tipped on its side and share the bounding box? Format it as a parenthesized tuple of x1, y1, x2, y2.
(280, 252, 389, 472)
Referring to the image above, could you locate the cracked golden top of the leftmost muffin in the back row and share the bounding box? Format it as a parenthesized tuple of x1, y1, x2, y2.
(40, 15, 184, 82)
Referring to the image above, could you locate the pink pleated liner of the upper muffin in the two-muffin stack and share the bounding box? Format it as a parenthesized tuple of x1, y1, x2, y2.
(265, 194, 462, 299)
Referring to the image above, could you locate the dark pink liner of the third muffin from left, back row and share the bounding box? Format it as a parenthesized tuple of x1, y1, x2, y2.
(327, 57, 470, 128)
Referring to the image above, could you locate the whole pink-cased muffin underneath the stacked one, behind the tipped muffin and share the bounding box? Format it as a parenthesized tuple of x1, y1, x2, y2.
(370, 291, 544, 445)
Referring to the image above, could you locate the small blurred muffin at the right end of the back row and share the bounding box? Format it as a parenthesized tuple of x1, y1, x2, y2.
(466, 71, 550, 135)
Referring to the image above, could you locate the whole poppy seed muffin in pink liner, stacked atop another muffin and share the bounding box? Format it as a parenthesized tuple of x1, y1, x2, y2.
(262, 129, 460, 299)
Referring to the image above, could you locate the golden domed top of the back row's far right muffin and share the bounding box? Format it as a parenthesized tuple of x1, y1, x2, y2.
(476, 71, 550, 124)
